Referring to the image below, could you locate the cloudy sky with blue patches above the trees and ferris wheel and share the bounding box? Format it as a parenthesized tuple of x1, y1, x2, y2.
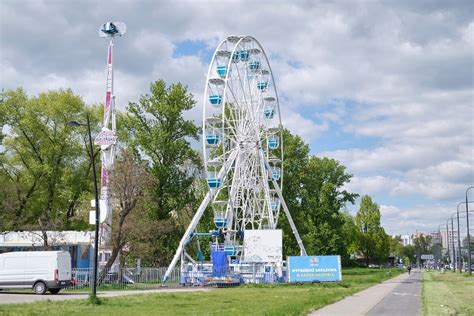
(0, 0, 474, 234)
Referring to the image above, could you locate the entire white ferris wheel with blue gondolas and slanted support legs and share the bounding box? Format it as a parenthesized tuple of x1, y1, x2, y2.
(164, 36, 306, 280)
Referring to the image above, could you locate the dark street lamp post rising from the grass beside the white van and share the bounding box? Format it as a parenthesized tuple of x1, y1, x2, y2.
(67, 114, 100, 297)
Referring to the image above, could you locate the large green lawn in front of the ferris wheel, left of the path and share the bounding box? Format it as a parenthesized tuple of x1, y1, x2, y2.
(0, 268, 402, 316)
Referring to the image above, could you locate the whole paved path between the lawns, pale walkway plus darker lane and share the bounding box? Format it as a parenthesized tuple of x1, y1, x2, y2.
(310, 272, 421, 316)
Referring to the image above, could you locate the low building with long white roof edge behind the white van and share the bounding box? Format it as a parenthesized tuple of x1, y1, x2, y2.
(0, 231, 94, 269)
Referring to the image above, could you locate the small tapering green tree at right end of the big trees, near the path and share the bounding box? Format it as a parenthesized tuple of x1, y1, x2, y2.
(356, 195, 390, 266)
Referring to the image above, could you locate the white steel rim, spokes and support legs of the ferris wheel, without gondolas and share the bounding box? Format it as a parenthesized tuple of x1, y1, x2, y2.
(163, 36, 306, 282)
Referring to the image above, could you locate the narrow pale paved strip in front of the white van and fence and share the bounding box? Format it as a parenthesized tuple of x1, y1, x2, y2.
(0, 287, 211, 304)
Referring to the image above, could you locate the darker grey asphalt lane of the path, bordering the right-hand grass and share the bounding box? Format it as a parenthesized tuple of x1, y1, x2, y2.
(367, 271, 422, 316)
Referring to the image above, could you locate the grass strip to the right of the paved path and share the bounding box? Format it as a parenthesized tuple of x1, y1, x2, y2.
(423, 271, 474, 315)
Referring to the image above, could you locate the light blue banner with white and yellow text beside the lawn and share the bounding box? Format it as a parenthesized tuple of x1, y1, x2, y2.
(288, 256, 342, 282)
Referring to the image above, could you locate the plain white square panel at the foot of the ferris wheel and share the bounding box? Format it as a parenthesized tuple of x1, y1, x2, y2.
(243, 229, 283, 263)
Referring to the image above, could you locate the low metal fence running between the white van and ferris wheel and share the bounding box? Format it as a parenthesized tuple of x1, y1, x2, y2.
(64, 268, 180, 291)
